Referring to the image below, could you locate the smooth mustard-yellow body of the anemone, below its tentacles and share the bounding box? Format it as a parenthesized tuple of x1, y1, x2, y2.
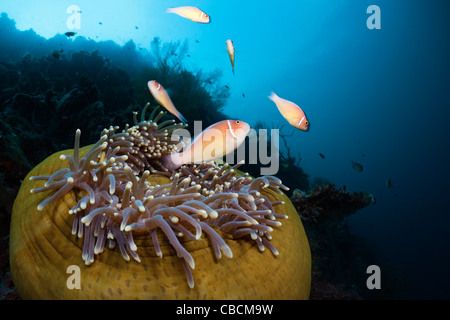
(10, 146, 311, 299)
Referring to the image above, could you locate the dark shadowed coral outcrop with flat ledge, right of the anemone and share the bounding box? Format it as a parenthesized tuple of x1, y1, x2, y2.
(291, 184, 379, 300)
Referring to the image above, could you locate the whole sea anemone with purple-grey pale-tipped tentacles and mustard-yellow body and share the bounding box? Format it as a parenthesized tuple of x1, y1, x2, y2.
(11, 104, 310, 298)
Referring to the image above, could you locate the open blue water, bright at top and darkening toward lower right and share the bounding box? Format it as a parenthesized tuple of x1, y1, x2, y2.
(0, 0, 450, 299)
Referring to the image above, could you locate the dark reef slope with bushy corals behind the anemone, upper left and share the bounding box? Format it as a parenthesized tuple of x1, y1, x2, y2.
(0, 13, 229, 184)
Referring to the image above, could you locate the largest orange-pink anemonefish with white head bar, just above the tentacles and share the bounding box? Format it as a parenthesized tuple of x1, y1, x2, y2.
(161, 120, 250, 171)
